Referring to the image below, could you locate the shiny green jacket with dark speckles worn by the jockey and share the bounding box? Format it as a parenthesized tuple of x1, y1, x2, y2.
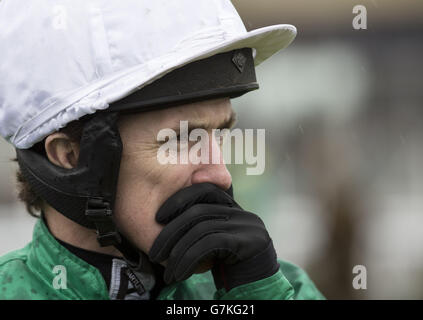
(0, 219, 324, 300)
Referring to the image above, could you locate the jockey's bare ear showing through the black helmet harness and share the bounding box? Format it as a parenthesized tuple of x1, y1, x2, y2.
(44, 132, 79, 169)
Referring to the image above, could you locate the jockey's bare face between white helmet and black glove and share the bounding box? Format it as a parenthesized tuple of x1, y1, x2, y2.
(115, 99, 234, 253)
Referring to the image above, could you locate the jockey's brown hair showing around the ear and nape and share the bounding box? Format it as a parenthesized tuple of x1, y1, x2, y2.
(13, 119, 85, 218)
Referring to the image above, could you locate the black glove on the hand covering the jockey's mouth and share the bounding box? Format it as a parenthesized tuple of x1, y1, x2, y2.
(149, 183, 279, 290)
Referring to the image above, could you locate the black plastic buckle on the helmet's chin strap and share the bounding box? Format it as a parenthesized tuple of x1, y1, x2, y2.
(85, 198, 122, 247)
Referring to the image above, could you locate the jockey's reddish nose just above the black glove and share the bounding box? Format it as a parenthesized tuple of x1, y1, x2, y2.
(191, 129, 232, 190)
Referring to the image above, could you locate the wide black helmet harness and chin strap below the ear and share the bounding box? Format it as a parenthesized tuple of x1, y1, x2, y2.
(16, 112, 154, 294)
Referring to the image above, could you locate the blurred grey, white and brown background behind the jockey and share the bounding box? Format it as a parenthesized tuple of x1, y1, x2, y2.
(0, 0, 423, 299)
